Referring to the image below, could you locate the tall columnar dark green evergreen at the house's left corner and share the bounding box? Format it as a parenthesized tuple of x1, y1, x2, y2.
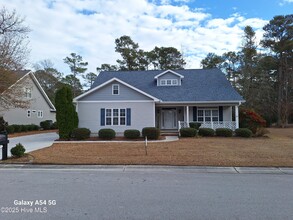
(55, 86, 78, 139)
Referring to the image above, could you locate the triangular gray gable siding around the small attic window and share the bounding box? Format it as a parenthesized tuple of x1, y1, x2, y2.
(79, 81, 152, 101)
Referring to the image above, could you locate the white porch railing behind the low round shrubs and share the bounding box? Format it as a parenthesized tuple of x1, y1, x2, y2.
(178, 121, 236, 131)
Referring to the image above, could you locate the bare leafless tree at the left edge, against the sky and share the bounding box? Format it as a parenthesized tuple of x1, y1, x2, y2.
(0, 7, 30, 110)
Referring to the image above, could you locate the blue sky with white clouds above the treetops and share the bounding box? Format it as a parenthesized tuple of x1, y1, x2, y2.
(0, 0, 293, 74)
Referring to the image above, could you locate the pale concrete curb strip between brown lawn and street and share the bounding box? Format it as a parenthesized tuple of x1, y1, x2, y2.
(0, 164, 293, 175)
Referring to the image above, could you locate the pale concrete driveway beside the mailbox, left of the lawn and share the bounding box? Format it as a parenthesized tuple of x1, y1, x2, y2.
(0, 132, 58, 160)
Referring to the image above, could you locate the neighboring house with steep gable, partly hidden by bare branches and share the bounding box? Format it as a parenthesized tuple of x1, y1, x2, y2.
(0, 70, 56, 125)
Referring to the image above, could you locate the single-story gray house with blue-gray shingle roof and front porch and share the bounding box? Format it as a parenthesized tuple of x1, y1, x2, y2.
(74, 69, 244, 133)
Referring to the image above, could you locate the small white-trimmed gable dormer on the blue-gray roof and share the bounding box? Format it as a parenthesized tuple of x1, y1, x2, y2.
(154, 70, 184, 86)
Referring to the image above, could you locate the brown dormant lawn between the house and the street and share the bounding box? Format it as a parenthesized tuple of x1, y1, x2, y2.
(2, 128, 293, 167)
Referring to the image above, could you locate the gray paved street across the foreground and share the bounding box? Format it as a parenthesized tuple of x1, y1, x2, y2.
(0, 165, 293, 220)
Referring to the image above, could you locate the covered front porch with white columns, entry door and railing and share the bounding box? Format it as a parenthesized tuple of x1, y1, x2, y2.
(156, 104, 239, 132)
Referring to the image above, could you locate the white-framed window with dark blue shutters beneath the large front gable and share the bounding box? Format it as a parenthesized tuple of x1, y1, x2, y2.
(101, 108, 131, 125)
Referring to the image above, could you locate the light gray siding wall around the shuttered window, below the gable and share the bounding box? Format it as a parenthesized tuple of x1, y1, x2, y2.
(77, 102, 155, 133)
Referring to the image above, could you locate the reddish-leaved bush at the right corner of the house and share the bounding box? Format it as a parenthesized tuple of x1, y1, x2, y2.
(239, 109, 266, 134)
